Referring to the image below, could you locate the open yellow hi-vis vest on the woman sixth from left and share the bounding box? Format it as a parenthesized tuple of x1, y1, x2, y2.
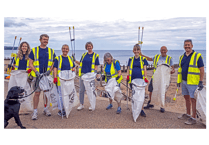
(128, 56, 147, 83)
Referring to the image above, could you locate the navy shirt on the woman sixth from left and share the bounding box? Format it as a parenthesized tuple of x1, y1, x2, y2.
(128, 57, 148, 80)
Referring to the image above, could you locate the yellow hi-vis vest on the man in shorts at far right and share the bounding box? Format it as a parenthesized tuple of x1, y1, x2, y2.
(177, 52, 202, 85)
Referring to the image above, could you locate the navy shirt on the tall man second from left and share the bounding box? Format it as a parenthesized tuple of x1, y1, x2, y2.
(29, 46, 56, 73)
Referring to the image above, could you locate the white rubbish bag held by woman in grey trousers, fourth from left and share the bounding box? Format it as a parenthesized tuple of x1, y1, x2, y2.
(81, 73, 97, 110)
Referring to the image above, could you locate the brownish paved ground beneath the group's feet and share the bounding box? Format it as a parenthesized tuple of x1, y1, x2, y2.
(4, 93, 206, 129)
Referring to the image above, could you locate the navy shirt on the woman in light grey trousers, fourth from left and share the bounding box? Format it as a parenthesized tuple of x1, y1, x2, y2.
(80, 53, 99, 73)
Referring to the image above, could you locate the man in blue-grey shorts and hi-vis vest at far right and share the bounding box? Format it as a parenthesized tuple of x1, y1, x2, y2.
(177, 39, 204, 125)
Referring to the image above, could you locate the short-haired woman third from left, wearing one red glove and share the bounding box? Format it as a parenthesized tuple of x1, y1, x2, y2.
(53, 44, 75, 116)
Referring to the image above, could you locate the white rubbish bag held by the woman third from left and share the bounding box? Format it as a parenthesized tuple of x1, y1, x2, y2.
(59, 70, 79, 118)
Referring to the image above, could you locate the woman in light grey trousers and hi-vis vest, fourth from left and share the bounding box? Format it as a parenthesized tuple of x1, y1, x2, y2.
(75, 42, 99, 111)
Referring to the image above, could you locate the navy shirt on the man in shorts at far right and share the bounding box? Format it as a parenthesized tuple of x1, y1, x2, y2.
(181, 50, 204, 81)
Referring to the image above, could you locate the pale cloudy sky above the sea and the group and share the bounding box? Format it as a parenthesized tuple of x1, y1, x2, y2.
(4, 17, 206, 50)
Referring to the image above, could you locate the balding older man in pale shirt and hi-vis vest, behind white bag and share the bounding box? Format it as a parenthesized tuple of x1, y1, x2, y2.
(140, 46, 175, 113)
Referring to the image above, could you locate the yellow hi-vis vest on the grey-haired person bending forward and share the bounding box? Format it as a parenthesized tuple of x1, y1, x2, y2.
(104, 60, 123, 84)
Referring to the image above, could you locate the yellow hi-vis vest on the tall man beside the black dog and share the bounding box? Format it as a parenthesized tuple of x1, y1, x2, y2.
(31, 46, 54, 77)
